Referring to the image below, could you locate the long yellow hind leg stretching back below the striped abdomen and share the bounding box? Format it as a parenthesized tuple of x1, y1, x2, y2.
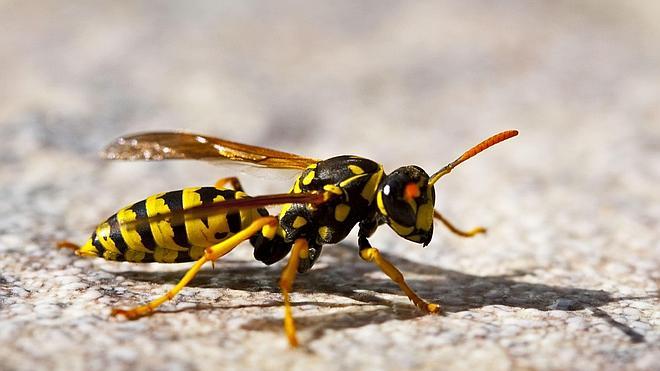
(111, 216, 278, 320)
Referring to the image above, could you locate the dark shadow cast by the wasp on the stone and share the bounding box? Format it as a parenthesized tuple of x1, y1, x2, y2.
(112, 244, 645, 342)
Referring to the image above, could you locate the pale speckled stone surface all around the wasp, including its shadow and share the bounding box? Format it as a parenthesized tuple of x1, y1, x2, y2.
(0, 0, 660, 370)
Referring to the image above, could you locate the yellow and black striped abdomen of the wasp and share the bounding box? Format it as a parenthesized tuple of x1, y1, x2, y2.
(79, 187, 267, 263)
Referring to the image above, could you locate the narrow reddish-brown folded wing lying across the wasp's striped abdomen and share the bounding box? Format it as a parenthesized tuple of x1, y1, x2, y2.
(122, 192, 329, 229)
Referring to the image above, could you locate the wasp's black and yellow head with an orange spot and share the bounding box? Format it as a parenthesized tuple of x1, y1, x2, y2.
(377, 165, 435, 246)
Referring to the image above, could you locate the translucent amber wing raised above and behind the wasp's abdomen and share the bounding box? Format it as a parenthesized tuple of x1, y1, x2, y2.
(101, 132, 319, 169)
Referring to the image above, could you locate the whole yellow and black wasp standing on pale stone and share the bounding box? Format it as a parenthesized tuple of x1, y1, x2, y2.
(58, 130, 518, 346)
